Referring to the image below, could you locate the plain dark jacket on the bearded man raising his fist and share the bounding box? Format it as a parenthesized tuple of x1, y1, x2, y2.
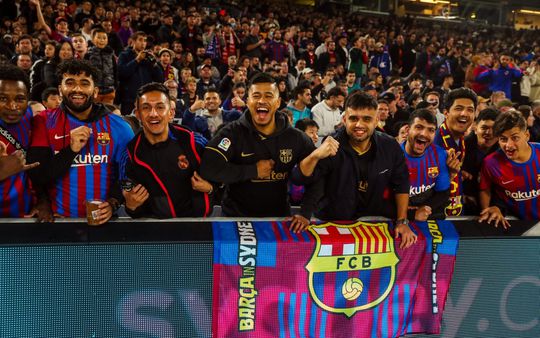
(293, 129, 409, 221)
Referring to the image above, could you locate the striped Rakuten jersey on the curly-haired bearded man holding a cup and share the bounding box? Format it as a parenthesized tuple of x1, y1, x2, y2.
(32, 108, 133, 217)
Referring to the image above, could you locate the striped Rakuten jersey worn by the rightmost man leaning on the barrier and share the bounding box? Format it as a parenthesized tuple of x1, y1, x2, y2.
(480, 143, 540, 220)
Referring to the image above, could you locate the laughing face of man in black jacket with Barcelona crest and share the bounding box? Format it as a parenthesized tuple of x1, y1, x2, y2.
(247, 82, 280, 135)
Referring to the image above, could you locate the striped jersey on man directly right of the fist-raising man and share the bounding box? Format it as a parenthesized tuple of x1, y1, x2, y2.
(401, 142, 450, 201)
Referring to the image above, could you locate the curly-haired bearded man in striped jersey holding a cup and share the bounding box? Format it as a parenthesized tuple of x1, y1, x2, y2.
(28, 60, 133, 223)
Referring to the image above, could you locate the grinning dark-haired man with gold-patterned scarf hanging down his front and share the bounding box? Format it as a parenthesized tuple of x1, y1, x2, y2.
(435, 88, 478, 216)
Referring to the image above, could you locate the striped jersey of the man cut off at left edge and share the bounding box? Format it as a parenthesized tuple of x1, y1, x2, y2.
(0, 107, 33, 217)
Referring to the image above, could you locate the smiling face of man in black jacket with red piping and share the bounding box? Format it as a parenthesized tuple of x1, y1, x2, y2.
(135, 91, 173, 144)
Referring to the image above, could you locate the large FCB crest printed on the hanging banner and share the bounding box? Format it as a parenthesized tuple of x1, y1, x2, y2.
(306, 222, 399, 317)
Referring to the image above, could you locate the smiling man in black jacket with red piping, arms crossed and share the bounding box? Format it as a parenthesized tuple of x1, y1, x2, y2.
(122, 82, 212, 218)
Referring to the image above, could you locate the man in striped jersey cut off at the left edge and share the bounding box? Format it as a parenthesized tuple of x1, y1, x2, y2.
(0, 64, 38, 217)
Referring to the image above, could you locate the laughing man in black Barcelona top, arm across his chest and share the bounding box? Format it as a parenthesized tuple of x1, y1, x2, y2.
(201, 73, 315, 231)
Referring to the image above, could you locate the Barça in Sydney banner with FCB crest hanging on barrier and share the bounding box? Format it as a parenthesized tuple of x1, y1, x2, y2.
(212, 221, 458, 338)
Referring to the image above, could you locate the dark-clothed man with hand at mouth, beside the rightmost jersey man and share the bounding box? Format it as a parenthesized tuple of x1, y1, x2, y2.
(462, 108, 499, 215)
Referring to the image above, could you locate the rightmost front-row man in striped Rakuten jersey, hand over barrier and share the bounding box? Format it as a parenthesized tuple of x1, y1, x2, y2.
(479, 110, 540, 228)
